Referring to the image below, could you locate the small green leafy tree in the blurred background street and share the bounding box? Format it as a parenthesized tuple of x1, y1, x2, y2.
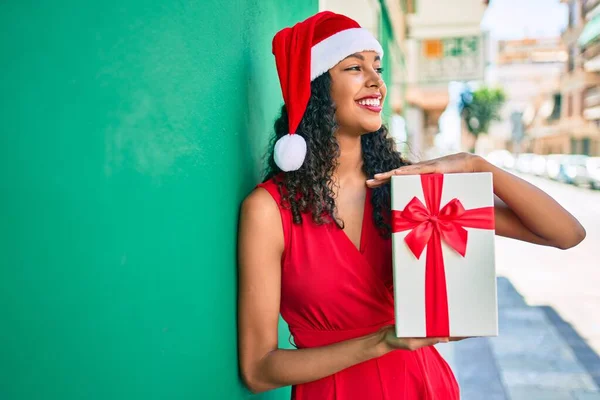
(461, 87, 506, 150)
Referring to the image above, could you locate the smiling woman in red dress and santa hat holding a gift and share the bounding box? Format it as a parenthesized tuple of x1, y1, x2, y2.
(238, 12, 585, 400)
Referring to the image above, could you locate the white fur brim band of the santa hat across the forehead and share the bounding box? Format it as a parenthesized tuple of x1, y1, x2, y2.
(310, 28, 383, 81)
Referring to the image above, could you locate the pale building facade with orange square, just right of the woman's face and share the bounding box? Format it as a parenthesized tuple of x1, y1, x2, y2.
(403, 0, 487, 159)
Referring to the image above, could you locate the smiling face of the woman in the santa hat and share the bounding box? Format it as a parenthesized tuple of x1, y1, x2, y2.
(329, 51, 387, 134)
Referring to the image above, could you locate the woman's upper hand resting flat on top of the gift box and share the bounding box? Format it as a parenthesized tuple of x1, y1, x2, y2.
(367, 153, 479, 188)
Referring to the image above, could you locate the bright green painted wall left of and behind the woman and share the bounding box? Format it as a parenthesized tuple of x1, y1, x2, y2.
(0, 0, 317, 400)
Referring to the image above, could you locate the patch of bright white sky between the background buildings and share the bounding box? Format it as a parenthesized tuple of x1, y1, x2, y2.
(481, 0, 568, 40)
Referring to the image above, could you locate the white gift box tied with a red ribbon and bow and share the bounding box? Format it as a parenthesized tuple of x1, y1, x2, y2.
(391, 172, 498, 337)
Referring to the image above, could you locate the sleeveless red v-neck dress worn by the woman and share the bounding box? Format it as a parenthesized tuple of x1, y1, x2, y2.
(258, 180, 460, 400)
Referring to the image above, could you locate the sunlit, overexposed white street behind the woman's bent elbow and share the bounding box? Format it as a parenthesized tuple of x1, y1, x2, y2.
(496, 176, 600, 354)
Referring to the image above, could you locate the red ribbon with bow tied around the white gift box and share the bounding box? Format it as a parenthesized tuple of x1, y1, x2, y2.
(392, 174, 494, 337)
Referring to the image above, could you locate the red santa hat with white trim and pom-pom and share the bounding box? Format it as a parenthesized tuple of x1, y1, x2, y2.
(273, 11, 383, 172)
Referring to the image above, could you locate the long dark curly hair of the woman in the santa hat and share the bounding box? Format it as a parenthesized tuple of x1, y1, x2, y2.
(264, 72, 408, 237)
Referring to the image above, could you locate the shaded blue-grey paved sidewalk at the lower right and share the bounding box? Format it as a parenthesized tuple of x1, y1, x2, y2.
(436, 277, 600, 400)
